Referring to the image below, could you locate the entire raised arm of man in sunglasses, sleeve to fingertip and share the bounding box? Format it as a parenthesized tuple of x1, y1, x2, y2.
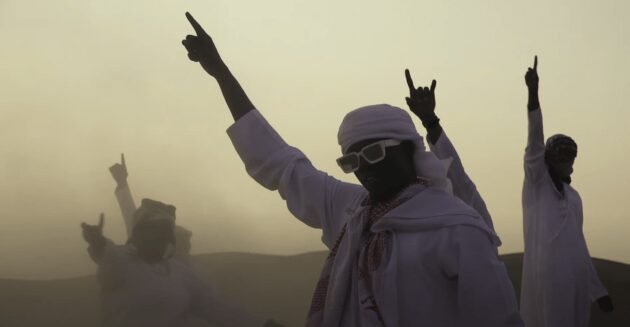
(182, 13, 365, 247)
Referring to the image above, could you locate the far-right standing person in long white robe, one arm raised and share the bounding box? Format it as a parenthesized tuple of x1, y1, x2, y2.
(521, 57, 613, 327)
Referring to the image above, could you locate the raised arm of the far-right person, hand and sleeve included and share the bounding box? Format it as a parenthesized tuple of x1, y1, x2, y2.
(525, 56, 547, 181)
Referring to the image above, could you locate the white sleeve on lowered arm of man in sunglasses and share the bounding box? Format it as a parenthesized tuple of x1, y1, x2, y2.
(454, 226, 523, 327)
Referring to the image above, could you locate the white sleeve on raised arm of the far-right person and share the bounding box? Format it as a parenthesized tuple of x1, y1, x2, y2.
(525, 108, 547, 182)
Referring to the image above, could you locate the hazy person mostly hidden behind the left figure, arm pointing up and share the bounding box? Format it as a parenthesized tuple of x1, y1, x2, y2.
(109, 154, 192, 264)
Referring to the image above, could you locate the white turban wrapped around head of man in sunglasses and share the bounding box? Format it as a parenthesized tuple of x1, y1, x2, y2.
(337, 104, 453, 194)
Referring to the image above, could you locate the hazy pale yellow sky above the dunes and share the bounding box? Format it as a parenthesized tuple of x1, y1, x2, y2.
(0, 0, 630, 278)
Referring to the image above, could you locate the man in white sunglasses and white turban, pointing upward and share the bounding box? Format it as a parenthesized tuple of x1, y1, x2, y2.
(183, 13, 522, 326)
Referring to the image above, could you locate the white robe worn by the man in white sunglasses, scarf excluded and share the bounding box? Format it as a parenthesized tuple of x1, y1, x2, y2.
(228, 110, 522, 327)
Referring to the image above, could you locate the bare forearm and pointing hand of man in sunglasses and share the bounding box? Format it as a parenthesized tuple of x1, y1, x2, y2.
(182, 13, 254, 121)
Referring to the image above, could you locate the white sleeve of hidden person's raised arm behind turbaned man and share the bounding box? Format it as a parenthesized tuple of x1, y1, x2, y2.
(428, 130, 494, 231)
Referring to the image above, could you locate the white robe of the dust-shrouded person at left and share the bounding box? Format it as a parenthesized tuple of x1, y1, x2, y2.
(88, 240, 263, 327)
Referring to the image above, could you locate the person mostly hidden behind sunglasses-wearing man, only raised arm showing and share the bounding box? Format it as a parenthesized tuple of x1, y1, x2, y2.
(405, 70, 502, 236)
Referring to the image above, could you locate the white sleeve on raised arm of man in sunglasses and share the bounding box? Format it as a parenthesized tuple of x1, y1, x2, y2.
(227, 110, 366, 248)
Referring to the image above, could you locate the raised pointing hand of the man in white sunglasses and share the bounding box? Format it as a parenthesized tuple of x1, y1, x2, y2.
(182, 12, 226, 78)
